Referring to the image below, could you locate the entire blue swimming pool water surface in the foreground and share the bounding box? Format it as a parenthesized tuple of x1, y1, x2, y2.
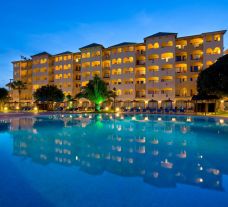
(0, 114, 228, 207)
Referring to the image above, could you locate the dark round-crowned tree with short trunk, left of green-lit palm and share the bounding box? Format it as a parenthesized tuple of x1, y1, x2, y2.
(33, 85, 64, 110)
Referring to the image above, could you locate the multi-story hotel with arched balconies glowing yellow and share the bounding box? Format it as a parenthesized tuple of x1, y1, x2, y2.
(12, 30, 226, 107)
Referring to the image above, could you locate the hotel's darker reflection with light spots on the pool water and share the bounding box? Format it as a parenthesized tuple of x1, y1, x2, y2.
(0, 115, 228, 191)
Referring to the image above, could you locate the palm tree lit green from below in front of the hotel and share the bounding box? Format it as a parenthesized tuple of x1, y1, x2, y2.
(76, 76, 116, 111)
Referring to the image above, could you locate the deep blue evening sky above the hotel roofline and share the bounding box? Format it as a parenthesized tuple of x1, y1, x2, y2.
(0, 0, 228, 87)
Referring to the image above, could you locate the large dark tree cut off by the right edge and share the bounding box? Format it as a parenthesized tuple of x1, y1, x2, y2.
(197, 55, 228, 97)
